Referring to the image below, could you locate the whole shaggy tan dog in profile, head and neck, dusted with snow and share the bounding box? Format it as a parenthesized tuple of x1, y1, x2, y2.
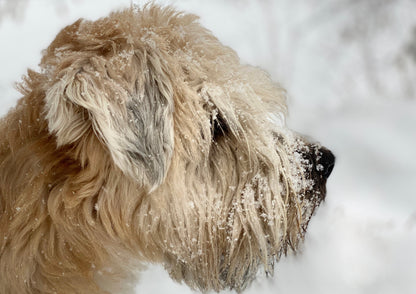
(0, 5, 334, 294)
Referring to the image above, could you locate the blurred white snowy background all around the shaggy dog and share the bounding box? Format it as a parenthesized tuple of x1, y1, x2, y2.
(0, 0, 416, 294)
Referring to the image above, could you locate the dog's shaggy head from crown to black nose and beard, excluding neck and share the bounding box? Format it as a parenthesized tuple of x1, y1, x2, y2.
(0, 7, 334, 290)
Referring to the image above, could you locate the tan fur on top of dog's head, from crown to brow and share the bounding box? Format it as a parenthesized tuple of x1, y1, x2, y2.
(41, 9, 286, 131)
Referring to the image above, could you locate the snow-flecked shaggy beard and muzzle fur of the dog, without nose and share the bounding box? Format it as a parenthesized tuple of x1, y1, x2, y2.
(153, 130, 325, 291)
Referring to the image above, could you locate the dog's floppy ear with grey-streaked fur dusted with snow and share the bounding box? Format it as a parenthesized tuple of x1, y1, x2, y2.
(45, 53, 174, 189)
